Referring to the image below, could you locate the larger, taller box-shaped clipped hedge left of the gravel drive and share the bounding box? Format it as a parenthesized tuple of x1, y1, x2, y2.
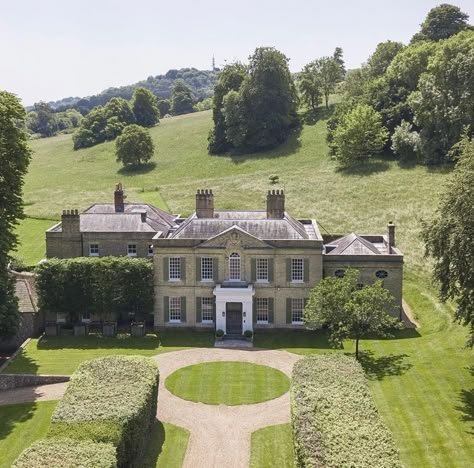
(48, 356, 159, 466)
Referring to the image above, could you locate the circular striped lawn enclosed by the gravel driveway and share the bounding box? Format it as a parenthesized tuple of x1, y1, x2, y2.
(165, 361, 290, 406)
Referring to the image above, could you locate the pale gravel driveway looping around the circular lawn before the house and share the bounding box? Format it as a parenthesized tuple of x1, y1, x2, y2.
(155, 348, 300, 468)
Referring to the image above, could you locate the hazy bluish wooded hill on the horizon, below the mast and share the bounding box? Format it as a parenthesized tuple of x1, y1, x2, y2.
(36, 68, 219, 115)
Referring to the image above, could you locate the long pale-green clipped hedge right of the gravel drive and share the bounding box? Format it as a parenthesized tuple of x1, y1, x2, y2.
(291, 354, 402, 468)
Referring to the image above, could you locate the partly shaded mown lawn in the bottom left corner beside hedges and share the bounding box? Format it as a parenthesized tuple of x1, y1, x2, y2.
(0, 401, 58, 468)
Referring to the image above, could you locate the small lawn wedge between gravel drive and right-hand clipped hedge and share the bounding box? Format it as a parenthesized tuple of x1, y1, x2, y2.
(250, 424, 295, 468)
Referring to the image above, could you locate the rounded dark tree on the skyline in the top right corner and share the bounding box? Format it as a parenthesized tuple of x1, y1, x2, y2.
(412, 3, 472, 42)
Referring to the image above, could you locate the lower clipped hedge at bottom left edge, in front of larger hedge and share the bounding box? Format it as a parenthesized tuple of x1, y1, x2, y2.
(13, 438, 117, 468)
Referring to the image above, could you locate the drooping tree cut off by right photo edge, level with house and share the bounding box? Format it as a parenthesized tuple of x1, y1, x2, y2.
(422, 139, 474, 347)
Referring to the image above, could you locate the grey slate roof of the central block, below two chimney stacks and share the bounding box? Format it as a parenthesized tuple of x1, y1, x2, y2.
(169, 210, 316, 240)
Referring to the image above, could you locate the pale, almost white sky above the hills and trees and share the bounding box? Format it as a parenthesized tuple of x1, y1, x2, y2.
(0, 0, 474, 105)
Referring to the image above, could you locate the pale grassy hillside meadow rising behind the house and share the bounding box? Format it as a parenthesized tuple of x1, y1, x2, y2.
(19, 108, 447, 268)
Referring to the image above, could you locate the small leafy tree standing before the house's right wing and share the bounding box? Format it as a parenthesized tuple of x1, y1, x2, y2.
(303, 268, 399, 359)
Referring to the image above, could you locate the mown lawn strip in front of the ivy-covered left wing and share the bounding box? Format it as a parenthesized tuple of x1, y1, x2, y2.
(4, 330, 214, 375)
